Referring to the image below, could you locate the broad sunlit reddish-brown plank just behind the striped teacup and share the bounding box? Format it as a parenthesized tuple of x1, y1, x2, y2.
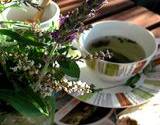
(104, 6, 160, 27)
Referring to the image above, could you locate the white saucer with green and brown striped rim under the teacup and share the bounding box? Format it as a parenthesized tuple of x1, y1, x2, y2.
(64, 38, 160, 108)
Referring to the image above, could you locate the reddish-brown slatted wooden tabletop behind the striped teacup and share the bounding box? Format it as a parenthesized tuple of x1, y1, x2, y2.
(58, 0, 160, 37)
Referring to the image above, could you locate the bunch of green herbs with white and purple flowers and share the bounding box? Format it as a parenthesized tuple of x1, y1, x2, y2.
(0, 0, 107, 124)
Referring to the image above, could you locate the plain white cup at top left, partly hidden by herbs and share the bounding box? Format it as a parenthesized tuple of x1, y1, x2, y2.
(2, 1, 60, 30)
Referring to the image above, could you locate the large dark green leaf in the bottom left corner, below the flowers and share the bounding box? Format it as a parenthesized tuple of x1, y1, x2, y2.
(0, 89, 42, 117)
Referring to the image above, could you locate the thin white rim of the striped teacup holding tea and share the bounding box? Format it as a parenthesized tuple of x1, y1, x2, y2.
(78, 20, 158, 65)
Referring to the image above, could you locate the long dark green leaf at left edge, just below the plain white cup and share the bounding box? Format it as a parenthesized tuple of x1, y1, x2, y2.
(0, 29, 43, 46)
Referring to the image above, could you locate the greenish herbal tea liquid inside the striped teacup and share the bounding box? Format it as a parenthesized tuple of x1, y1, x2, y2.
(87, 36, 146, 63)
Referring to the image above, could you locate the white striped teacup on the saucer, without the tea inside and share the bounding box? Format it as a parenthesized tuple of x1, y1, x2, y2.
(79, 21, 158, 83)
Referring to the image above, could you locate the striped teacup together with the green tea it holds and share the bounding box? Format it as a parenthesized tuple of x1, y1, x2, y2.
(79, 20, 158, 84)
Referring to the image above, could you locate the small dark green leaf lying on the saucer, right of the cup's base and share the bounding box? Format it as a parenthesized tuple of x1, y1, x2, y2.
(125, 74, 141, 88)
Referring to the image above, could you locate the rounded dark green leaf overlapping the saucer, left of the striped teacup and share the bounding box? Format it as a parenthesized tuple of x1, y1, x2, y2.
(58, 60, 80, 79)
